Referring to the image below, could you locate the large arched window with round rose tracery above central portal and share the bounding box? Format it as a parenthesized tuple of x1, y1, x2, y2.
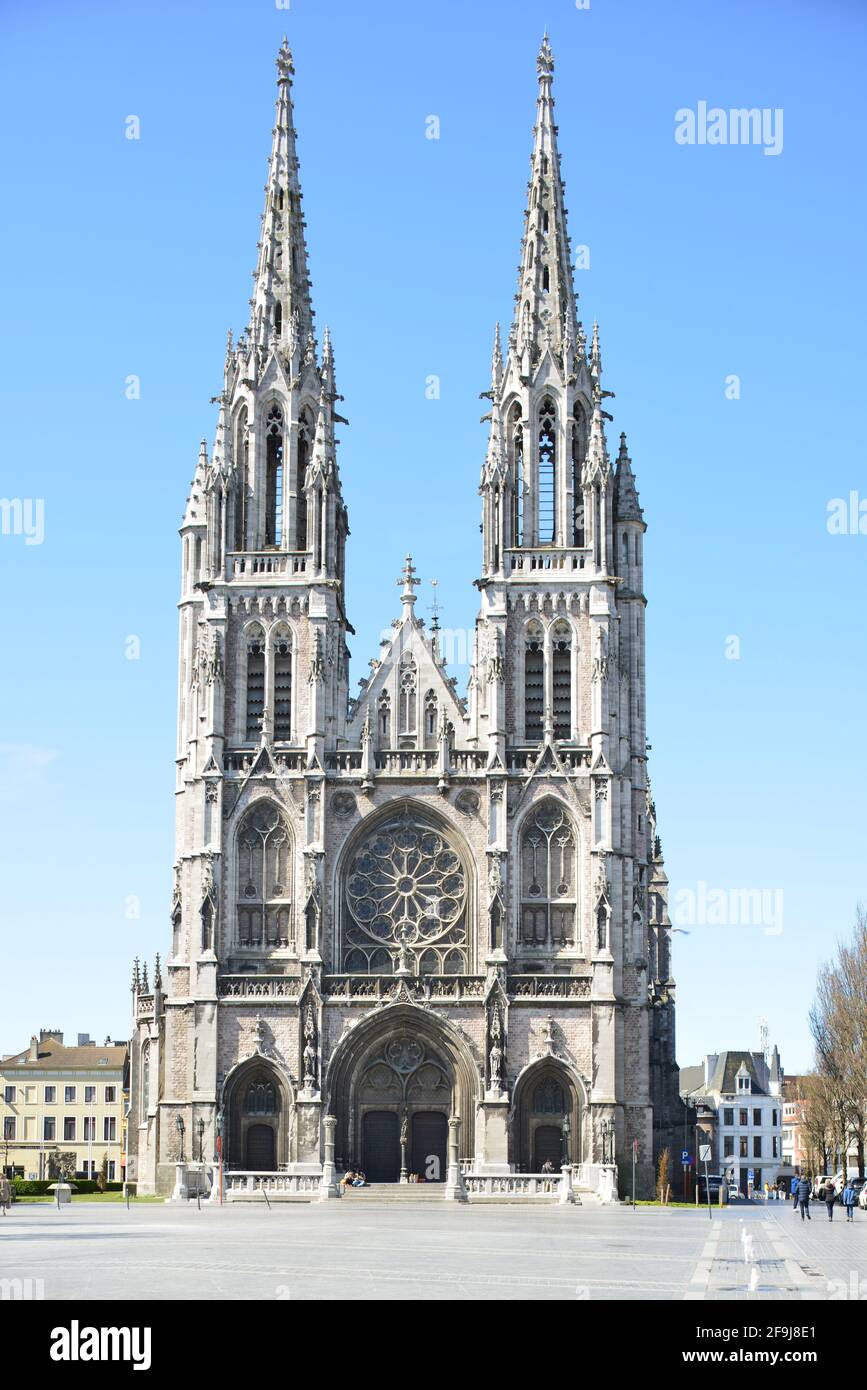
(345, 816, 467, 974)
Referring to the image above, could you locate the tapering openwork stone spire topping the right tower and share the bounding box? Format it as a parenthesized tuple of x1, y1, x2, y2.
(511, 33, 581, 374)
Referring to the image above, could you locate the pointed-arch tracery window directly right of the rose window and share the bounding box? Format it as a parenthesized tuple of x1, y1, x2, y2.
(518, 801, 577, 949)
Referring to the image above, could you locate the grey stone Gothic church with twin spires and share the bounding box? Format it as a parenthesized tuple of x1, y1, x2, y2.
(128, 38, 679, 1195)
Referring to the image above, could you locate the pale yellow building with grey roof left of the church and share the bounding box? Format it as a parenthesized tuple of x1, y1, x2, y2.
(0, 1029, 128, 1182)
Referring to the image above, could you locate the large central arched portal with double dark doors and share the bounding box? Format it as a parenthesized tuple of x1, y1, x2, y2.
(327, 1004, 479, 1182)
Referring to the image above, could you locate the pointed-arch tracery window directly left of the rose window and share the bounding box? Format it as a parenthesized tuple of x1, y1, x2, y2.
(238, 803, 292, 947)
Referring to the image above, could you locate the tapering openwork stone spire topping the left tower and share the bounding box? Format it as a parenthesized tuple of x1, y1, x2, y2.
(249, 39, 314, 350)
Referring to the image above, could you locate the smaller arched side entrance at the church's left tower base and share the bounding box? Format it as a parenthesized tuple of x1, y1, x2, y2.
(222, 1056, 293, 1173)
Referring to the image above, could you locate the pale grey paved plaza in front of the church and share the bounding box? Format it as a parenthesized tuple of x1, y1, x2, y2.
(0, 1201, 867, 1301)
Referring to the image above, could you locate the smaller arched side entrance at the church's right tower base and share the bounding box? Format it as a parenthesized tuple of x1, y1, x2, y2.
(511, 1058, 582, 1173)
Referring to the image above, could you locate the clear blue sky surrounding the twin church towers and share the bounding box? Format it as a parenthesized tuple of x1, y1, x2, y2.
(0, 0, 867, 1070)
